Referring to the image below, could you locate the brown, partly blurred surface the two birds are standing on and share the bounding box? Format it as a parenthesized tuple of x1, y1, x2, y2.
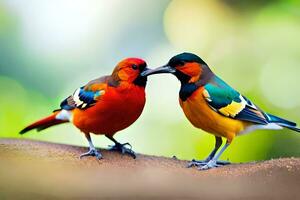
(0, 139, 300, 200)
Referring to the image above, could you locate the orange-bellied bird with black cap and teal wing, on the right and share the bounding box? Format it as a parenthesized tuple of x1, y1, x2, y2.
(142, 52, 300, 170)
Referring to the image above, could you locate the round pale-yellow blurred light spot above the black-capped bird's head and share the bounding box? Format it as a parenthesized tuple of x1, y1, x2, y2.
(164, 0, 234, 53)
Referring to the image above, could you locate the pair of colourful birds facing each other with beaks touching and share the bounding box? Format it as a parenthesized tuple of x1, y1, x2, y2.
(20, 53, 300, 169)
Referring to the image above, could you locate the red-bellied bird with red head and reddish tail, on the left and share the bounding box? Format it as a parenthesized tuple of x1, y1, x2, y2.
(20, 58, 147, 159)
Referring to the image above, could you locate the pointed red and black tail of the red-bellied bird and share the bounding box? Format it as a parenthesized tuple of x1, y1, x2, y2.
(20, 111, 68, 134)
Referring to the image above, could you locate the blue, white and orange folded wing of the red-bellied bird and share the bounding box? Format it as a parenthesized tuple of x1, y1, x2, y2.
(60, 76, 109, 110)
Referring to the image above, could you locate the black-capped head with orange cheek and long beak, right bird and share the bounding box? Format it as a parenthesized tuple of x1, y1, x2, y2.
(141, 53, 213, 84)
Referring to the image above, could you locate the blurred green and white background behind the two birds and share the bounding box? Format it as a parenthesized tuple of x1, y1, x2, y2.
(0, 0, 300, 162)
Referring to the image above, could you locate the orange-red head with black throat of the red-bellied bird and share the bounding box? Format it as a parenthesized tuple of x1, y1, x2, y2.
(112, 58, 148, 87)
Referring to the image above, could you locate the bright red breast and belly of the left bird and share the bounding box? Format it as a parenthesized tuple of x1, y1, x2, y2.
(73, 84, 146, 135)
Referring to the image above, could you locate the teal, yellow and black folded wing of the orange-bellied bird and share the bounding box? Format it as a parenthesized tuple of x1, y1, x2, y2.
(203, 76, 268, 124)
